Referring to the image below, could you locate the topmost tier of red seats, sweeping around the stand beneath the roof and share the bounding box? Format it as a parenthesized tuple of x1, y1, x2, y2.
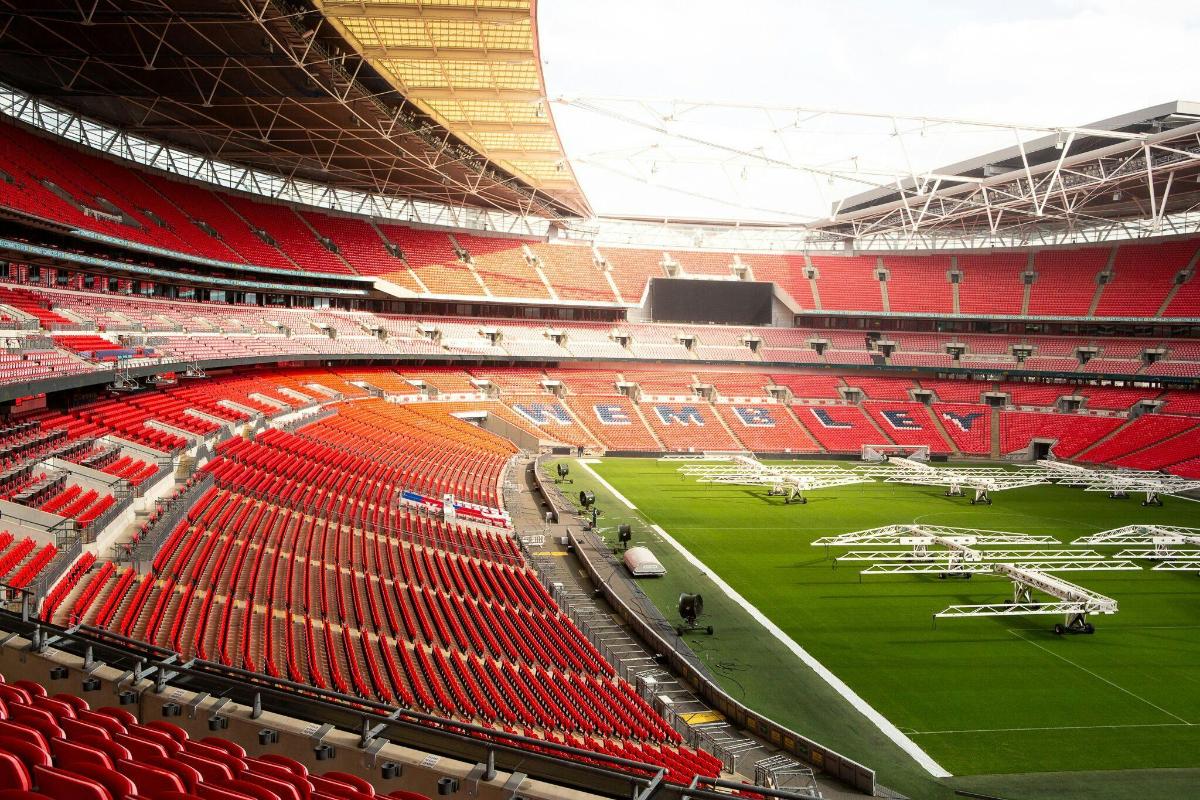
(0, 115, 1200, 328)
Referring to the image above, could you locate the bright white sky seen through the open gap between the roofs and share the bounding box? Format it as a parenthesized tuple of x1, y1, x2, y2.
(538, 0, 1200, 222)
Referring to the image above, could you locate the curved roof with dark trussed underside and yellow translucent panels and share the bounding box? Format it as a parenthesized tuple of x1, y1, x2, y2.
(0, 0, 589, 218)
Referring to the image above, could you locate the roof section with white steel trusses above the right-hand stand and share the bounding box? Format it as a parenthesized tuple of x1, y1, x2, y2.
(814, 101, 1200, 247)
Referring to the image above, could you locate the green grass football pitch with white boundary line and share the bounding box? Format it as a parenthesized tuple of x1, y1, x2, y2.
(564, 458, 1200, 798)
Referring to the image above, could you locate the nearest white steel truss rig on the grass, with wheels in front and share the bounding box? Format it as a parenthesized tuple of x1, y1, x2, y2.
(812, 525, 1141, 633)
